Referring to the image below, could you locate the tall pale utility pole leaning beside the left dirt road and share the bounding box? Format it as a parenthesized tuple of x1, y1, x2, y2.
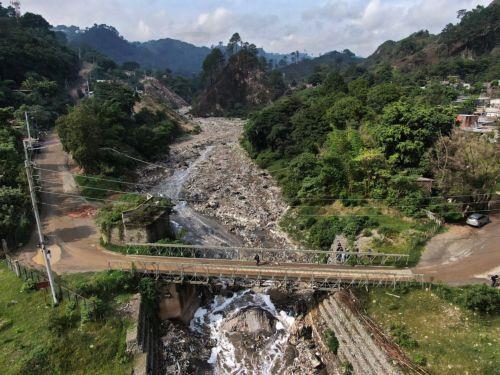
(23, 119, 58, 305)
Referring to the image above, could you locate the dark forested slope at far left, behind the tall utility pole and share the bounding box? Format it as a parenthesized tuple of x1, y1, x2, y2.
(0, 5, 79, 250)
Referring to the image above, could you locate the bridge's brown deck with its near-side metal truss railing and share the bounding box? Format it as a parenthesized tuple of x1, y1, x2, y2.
(108, 260, 424, 290)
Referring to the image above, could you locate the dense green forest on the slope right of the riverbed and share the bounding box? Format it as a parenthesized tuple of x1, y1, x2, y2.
(242, 4, 500, 260)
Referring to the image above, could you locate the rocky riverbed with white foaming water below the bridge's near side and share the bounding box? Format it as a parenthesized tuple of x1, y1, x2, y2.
(158, 289, 324, 375)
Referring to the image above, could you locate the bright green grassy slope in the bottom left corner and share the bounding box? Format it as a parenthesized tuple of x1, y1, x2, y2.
(0, 263, 132, 374)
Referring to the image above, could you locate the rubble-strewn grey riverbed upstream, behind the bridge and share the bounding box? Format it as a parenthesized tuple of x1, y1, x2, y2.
(141, 118, 294, 247)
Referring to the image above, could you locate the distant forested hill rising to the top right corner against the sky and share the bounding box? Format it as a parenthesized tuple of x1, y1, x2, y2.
(363, 0, 500, 79)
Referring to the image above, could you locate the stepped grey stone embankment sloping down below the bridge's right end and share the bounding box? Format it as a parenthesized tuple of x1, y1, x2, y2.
(306, 291, 426, 375)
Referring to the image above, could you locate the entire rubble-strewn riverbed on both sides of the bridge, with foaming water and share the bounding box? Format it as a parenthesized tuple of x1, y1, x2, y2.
(141, 118, 328, 374)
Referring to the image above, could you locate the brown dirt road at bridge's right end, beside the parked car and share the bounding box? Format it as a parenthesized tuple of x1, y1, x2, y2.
(414, 215, 500, 285)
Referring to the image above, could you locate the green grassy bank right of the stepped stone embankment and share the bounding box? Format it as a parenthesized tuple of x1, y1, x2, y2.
(363, 288, 500, 375)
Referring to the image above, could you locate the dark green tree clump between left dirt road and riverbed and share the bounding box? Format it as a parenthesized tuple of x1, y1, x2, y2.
(56, 82, 180, 175)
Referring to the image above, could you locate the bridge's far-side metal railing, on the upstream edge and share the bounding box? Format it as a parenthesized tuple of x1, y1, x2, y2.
(126, 243, 409, 266)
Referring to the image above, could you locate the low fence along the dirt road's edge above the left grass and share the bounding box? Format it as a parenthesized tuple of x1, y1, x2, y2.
(5, 256, 97, 311)
